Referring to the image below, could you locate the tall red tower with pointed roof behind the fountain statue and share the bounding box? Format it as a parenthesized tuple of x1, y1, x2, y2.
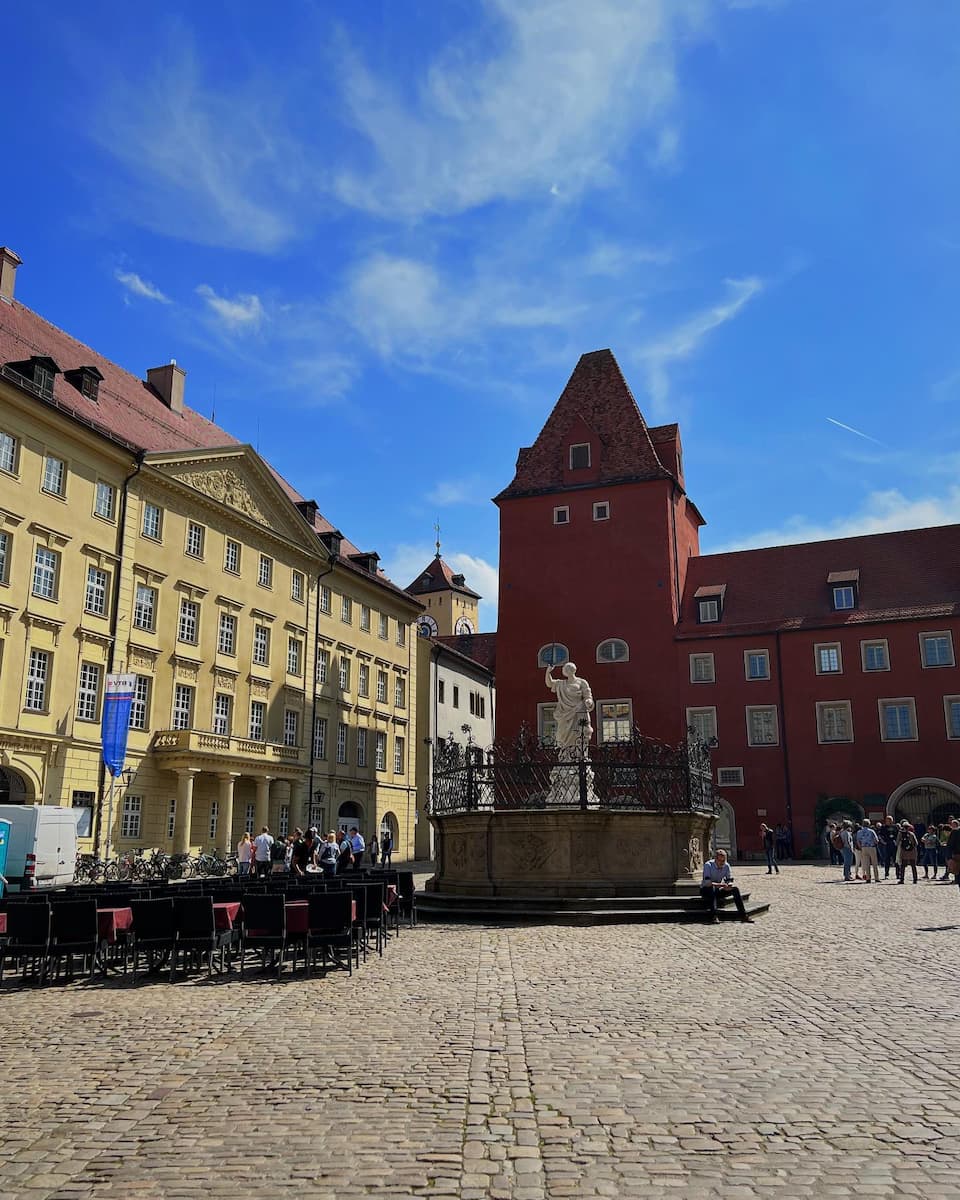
(496, 350, 703, 743)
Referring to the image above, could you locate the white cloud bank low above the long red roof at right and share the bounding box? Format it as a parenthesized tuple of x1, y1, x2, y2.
(708, 486, 960, 553)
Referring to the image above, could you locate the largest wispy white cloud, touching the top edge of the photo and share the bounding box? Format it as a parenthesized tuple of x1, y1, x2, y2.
(335, 0, 704, 217)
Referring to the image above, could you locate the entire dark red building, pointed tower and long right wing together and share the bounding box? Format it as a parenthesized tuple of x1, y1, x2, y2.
(496, 350, 960, 851)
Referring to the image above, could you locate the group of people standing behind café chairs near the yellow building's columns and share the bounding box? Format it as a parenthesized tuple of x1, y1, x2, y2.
(236, 826, 394, 876)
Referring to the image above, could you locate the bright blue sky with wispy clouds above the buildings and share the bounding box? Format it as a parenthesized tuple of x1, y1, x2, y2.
(0, 0, 960, 628)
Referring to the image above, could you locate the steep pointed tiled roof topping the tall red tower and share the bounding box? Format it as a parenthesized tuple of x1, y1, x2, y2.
(497, 350, 670, 500)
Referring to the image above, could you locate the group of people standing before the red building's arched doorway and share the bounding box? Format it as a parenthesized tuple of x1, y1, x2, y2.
(827, 815, 960, 883)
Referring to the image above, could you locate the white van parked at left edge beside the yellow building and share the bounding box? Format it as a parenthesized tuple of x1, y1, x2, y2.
(0, 804, 84, 892)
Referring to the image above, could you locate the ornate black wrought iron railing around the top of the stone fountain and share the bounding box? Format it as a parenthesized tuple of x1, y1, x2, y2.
(430, 730, 718, 816)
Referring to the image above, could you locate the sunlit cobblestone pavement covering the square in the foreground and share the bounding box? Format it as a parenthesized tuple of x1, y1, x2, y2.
(0, 866, 960, 1200)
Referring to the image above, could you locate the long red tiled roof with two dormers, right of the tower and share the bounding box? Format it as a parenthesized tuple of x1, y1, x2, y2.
(677, 524, 960, 637)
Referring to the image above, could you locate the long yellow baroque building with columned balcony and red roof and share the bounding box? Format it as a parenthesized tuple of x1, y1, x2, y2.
(0, 248, 422, 858)
